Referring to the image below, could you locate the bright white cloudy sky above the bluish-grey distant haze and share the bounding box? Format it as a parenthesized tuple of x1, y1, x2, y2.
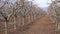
(29, 0, 51, 8)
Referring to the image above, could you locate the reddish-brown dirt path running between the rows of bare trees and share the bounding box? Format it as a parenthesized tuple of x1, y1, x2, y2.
(0, 15, 56, 34)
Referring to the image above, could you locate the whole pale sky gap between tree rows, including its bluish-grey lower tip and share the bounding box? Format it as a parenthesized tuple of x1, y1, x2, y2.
(29, 0, 52, 11)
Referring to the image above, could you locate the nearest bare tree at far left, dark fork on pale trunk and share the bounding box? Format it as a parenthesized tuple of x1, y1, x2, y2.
(0, 0, 20, 34)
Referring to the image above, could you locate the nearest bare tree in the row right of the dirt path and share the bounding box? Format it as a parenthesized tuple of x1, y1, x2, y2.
(48, 0, 60, 30)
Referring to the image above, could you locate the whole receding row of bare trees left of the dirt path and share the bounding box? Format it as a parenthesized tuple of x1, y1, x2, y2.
(0, 0, 46, 34)
